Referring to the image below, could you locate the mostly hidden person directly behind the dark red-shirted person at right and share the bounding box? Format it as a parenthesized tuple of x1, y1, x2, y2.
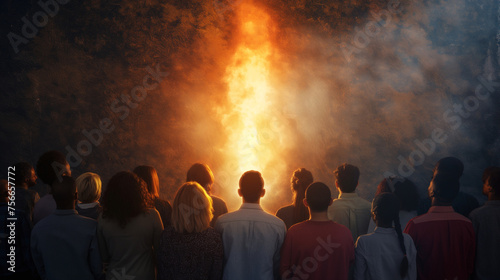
(419, 157, 479, 217)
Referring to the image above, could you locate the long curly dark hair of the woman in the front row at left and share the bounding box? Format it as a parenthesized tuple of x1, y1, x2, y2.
(102, 171, 153, 228)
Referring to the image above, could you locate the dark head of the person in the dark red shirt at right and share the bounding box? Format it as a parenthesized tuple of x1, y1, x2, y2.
(428, 173, 460, 206)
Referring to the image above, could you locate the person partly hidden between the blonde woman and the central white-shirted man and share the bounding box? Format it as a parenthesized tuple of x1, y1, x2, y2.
(186, 163, 227, 227)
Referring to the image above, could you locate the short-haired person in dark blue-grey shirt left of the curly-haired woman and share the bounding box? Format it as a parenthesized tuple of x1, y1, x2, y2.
(31, 177, 102, 280)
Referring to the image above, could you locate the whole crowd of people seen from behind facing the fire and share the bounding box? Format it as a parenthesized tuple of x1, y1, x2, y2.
(0, 151, 500, 280)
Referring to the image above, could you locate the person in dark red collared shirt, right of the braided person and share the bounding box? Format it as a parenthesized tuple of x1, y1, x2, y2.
(404, 173, 476, 280)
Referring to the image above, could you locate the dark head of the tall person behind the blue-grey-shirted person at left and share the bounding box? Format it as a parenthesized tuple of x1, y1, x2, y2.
(36, 151, 71, 185)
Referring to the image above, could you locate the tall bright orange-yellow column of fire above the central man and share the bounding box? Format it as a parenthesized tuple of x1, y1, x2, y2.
(217, 4, 286, 210)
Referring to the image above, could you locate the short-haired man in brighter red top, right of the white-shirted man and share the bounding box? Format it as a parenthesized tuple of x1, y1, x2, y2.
(280, 182, 354, 280)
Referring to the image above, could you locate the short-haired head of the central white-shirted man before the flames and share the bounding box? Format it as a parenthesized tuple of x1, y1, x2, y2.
(238, 170, 266, 203)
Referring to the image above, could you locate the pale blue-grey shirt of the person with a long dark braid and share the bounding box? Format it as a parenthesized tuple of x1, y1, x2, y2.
(354, 227, 417, 280)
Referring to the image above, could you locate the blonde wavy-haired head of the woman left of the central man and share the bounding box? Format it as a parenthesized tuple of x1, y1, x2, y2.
(172, 182, 213, 233)
